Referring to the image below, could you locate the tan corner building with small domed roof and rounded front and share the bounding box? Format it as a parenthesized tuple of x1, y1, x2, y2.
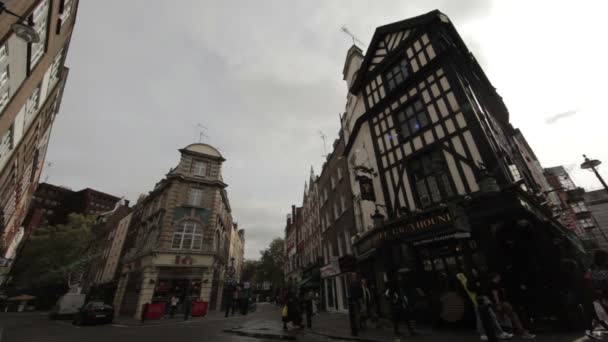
(115, 144, 242, 317)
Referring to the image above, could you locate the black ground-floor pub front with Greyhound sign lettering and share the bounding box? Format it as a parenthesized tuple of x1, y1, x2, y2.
(355, 191, 583, 325)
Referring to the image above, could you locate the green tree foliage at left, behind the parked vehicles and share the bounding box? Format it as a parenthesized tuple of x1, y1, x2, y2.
(12, 214, 95, 292)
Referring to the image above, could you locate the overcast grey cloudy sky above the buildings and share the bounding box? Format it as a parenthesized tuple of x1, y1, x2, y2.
(43, 0, 608, 258)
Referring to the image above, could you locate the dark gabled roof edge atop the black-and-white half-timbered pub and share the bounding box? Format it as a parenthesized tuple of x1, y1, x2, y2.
(351, 10, 448, 93)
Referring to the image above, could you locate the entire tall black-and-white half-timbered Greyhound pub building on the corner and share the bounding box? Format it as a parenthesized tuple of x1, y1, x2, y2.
(342, 11, 584, 322)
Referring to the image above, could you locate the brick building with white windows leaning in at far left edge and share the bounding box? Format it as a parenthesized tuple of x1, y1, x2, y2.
(0, 0, 79, 283)
